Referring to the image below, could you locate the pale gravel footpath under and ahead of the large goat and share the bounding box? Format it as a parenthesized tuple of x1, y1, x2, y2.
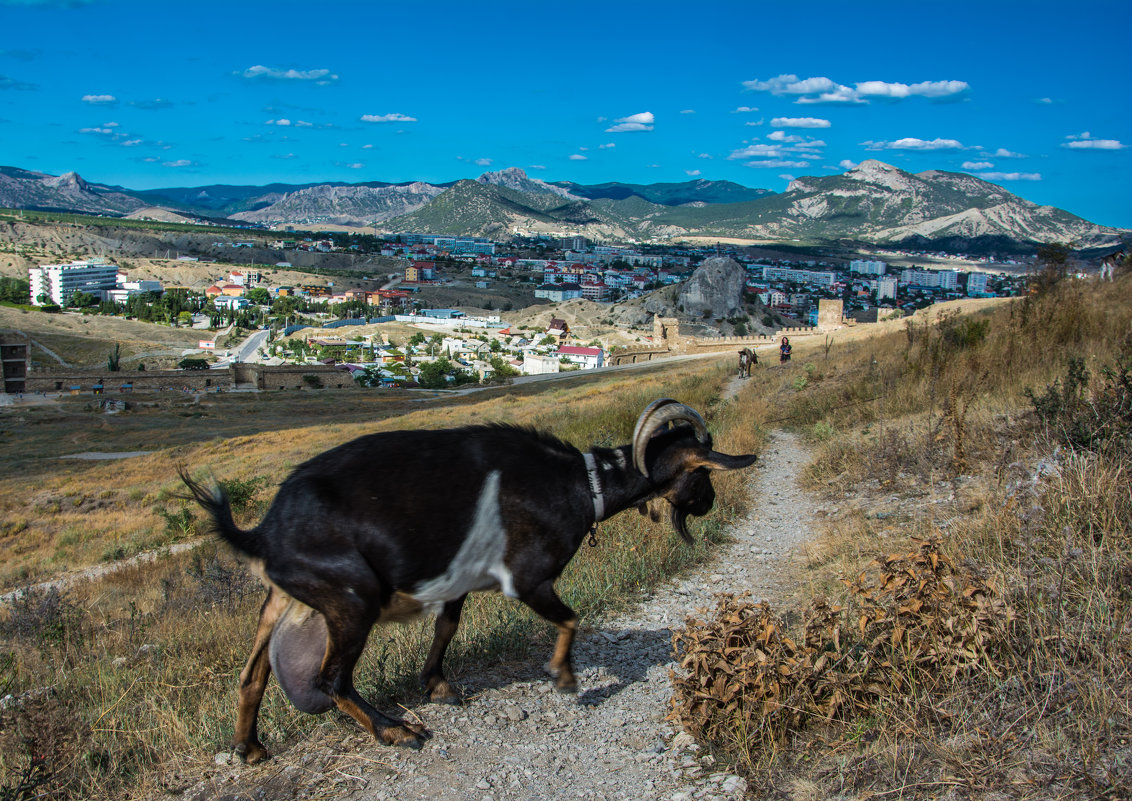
(185, 423, 814, 801)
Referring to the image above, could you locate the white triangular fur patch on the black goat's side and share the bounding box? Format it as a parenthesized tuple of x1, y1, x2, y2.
(412, 471, 515, 611)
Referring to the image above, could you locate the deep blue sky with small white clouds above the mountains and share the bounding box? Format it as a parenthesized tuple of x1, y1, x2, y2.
(0, 0, 1132, 227)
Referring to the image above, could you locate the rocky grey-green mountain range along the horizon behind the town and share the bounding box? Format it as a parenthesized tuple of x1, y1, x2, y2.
(0, 160, 1132, 252)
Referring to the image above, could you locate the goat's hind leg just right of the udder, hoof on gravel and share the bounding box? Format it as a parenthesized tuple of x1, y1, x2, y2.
(316, 609, 431, 748)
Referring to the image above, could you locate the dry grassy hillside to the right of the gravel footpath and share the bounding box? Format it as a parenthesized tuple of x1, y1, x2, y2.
(680, 273, 1132, 799)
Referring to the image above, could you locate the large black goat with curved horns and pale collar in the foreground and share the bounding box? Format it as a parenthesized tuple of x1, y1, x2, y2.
(180, 398, 756, 763)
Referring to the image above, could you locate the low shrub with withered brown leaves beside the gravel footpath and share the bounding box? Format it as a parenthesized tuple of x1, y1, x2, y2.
(670, 540, 1013, 752)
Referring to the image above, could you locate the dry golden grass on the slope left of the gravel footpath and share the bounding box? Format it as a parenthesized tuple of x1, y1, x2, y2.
(0, 361, 761, 798)
